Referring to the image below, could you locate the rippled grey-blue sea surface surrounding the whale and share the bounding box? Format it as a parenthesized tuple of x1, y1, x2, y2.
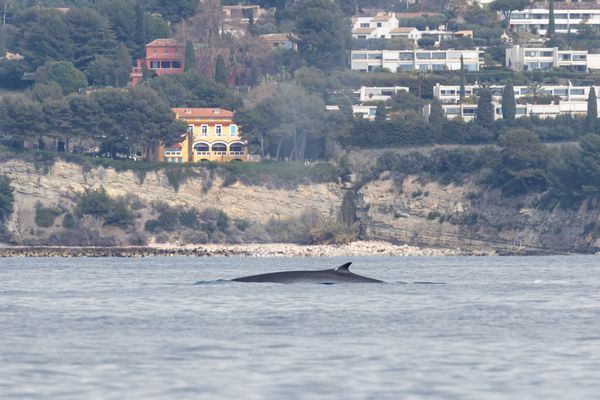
(0, 256, 600, 399)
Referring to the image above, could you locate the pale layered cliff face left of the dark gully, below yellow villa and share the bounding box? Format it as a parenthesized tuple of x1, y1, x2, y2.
(0, 160, 343, 242)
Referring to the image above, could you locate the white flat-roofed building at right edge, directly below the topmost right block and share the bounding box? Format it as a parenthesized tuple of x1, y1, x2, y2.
(506, 45, 600, 72)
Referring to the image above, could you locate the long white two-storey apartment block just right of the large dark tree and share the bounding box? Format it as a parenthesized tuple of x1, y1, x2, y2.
(351, 48, 483, 72)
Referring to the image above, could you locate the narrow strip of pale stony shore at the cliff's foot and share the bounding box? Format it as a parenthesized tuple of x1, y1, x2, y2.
(0, 241, 478, 257)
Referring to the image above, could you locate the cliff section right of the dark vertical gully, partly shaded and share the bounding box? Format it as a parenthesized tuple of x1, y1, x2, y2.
(357, 174, 600, 254)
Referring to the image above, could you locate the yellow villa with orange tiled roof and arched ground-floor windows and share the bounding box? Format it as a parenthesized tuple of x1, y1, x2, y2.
(158, 108, 248, 163)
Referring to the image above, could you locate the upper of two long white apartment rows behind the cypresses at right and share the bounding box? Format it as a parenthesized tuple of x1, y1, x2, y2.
(433, 83, 600, 104)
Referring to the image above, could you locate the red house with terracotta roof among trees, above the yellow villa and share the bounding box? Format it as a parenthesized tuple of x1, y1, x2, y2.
(130, 39, 185, 86)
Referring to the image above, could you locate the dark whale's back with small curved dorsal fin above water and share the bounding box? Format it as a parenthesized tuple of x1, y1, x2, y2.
(232, 262, 384, 284)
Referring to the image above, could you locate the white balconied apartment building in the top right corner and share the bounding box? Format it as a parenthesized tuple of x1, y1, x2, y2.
(508, 2, 600, 35)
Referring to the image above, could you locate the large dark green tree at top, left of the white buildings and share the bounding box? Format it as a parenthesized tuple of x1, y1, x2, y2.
(291, 0, 351, 71)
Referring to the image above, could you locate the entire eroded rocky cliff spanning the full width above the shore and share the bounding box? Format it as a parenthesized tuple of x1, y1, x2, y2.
(0, 160, 600, 254)
